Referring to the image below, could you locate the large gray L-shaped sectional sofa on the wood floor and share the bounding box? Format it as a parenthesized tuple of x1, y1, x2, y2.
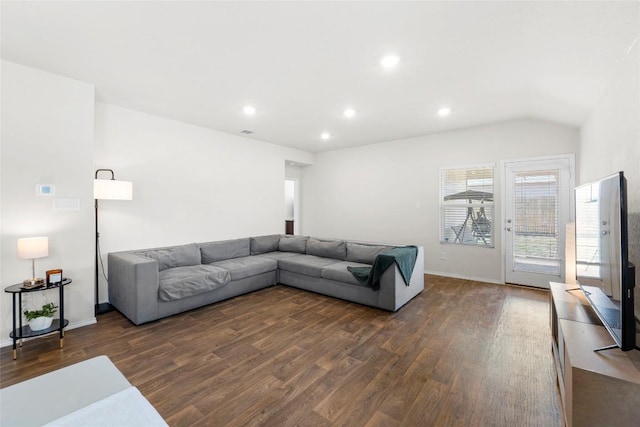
(108, 235, 424, 325)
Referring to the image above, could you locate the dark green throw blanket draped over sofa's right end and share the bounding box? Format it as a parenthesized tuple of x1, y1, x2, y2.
(347, 246, 418, 290)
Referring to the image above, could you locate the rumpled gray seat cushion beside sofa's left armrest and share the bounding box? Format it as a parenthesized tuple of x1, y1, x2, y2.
(158, 264, 231, 301)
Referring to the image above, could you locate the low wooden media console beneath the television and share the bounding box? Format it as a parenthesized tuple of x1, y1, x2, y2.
(549, 282, 640, 426)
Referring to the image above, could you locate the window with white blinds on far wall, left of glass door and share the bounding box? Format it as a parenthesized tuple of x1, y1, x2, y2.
(440, 165, 494, 248)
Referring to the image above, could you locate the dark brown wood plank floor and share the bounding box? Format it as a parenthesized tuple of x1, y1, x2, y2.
(0, 276, 562, 426)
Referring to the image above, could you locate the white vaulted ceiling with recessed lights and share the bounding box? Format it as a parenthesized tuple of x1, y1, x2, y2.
(1, 1, 640, 152)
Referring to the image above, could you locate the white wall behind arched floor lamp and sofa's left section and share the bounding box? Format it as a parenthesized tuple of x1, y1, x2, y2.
(95, 103, 313, 301)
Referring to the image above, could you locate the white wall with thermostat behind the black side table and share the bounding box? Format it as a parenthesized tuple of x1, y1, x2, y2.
(0, 61, 95, 345)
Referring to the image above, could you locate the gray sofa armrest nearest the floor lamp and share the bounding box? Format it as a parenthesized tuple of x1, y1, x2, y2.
(108, 252, 159, 325)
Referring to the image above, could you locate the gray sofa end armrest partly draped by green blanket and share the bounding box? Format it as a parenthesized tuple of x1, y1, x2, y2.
(378, 246, 424, 311)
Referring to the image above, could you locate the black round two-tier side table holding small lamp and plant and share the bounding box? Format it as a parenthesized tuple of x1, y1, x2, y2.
(4, 278, 71, 360)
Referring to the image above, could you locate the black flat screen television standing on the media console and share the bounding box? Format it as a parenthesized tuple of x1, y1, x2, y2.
(575, 172, 637, 351)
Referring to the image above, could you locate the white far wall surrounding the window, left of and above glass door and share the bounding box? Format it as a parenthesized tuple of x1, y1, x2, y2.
(302, 120, 578, 282)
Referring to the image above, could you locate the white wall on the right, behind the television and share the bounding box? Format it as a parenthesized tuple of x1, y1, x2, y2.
(578, 42, 640, 316)
